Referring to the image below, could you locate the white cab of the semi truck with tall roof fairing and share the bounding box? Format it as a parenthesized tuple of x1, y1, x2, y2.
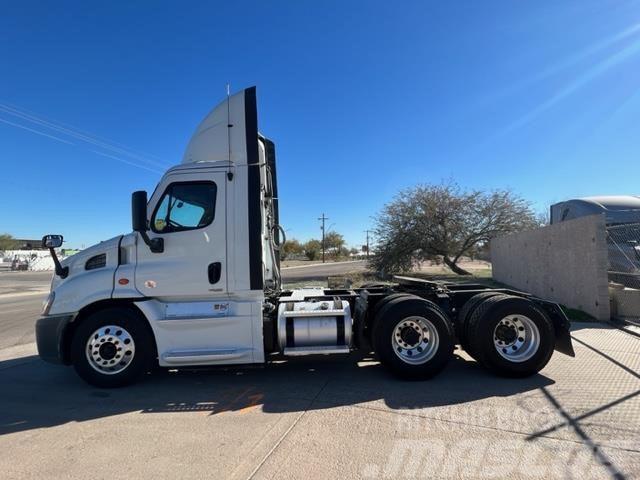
(37, 87, 281, 384)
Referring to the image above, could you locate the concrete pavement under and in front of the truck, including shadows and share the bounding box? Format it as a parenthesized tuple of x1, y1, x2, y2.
(0, 275, 640, 480)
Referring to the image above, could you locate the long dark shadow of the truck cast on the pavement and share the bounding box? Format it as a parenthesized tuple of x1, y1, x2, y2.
(0, 354, 554, 435)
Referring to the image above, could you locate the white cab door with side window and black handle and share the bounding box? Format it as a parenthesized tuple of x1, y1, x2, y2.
(135, 172, 227, 302)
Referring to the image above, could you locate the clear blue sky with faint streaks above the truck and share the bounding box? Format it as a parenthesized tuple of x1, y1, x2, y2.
(0, 0, 640, 247)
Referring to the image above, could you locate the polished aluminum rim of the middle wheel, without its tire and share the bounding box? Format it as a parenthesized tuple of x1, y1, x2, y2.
(391, 317, 440, 365)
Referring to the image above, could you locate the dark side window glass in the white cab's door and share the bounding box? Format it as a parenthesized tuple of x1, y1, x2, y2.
(151, 182, 216, 233)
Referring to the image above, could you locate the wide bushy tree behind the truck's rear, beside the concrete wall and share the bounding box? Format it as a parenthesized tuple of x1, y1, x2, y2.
(372, 182, 539, 275)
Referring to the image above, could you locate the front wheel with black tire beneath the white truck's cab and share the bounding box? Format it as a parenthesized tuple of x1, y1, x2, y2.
(71, 307, 156, 388)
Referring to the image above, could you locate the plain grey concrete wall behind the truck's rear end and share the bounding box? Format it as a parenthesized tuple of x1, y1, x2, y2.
(491, 215, 611, 320)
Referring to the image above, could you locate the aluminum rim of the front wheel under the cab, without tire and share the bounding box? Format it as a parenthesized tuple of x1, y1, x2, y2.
(85, 325, 136, 375)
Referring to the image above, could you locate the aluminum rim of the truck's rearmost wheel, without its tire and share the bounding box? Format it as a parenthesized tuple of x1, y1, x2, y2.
(493, 315, 540, 363)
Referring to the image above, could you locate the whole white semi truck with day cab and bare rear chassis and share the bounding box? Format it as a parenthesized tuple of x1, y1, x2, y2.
(36, 87, 573, 387)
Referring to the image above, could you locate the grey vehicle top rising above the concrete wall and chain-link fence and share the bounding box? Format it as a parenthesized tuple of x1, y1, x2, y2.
(550, 195, 640, 225)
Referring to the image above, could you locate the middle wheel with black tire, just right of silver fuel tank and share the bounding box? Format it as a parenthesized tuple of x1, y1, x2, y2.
(373, 297, 453, 380)
